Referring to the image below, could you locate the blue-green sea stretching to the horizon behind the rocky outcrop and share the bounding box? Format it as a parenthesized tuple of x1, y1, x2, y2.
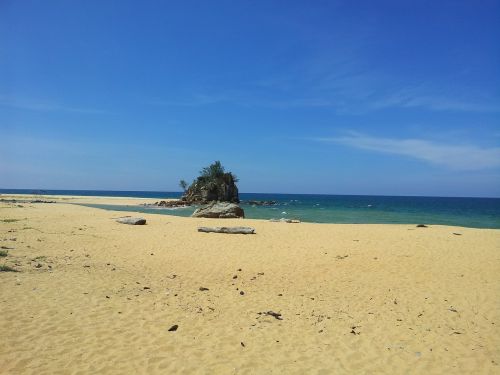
(0, 189, 500, 229)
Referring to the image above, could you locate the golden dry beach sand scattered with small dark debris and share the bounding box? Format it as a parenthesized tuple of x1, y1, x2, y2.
(0, 197, 500, 375)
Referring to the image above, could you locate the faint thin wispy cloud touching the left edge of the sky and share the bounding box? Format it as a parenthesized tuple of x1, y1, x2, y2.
(0, 95, 107, 114)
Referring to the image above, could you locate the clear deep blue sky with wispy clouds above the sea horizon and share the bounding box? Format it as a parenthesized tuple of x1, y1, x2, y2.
(0, 0, 500, 197)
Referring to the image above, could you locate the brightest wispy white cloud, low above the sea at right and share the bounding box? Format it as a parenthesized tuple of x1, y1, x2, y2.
(314, 133, 500, 170)
